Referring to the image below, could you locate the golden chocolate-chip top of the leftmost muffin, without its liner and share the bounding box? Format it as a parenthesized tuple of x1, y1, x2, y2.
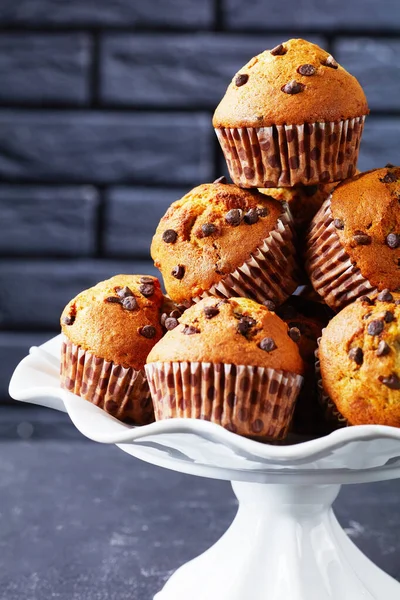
(61, 275, 164, 370)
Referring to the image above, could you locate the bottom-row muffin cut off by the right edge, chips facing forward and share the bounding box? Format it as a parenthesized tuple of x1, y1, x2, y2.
(319, 290, 400, 427)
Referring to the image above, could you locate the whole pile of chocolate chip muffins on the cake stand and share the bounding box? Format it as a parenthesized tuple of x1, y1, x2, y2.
(61, 40, 400, 441)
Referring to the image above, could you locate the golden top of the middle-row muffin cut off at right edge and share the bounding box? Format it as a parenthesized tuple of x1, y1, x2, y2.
(331, 166, 400, 290)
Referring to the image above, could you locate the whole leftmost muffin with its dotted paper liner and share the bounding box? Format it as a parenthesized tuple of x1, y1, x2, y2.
(61, 275, 164, 425)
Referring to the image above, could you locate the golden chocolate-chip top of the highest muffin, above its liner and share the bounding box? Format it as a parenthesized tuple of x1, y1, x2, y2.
(213, 39, 369, 128)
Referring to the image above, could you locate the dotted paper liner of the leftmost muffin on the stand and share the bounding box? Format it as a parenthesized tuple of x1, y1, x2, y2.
(60, 337, 154, 425)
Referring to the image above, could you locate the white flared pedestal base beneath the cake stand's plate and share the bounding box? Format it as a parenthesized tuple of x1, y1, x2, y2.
(154, 482, 400, 600)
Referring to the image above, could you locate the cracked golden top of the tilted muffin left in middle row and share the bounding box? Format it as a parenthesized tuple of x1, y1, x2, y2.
(151, 183, 284, 304)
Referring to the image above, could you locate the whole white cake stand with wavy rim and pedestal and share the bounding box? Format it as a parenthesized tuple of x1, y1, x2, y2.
(10, 337, 400, 600)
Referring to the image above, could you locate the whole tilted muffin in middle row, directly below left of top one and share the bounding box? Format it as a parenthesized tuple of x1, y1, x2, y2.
(151, 180, 299, 306)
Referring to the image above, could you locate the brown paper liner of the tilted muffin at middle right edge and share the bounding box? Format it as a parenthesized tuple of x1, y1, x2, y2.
(306, 197, 377, 310)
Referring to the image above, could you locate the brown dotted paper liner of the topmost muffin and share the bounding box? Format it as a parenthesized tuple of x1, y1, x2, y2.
(215, 116, 365, 188)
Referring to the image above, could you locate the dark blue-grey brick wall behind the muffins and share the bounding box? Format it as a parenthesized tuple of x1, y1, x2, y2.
(0, 0, 400, 401)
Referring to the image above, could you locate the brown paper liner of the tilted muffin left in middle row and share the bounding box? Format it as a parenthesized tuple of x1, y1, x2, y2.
(192, 211, 301, 305)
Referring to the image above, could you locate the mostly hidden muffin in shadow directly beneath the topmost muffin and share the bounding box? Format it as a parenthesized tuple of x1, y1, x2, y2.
(259, 182, 337, 233)
